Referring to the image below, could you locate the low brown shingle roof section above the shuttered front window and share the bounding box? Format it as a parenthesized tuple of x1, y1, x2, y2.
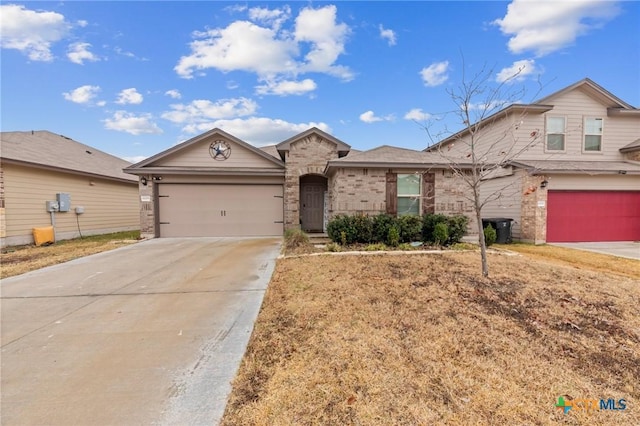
(325, 145, 471, 173)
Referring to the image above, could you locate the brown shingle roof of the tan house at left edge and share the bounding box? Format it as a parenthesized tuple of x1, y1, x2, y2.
(0, 130, 137, 182)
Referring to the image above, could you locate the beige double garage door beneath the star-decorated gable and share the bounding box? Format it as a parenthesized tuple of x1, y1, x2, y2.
(158, 184, 283, 237)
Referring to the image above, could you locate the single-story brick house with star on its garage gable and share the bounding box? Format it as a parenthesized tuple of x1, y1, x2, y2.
(124, 128, 476, 237)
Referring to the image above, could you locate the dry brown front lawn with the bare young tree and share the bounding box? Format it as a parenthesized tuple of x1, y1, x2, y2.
(222, 252, 640, 425)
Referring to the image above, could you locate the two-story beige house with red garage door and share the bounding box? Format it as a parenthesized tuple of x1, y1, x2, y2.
(425, 79, 640, 244)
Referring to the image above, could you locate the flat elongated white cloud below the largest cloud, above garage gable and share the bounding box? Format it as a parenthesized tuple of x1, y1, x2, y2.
(162, 98, 258, 127)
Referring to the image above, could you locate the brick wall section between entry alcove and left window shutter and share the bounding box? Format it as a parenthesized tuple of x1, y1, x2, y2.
(329, 168, 387, 216)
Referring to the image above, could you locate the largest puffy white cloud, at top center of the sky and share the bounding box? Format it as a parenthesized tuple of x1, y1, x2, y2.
(174, 6, 353, 80)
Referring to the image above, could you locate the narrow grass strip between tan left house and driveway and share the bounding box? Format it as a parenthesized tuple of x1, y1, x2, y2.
(0, 231, 140, 278)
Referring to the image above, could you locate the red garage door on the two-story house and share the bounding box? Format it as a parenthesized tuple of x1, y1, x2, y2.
(547, 191, 640, 243)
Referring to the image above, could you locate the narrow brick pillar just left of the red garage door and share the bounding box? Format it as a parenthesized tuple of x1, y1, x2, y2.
(520, 174, 547, 244)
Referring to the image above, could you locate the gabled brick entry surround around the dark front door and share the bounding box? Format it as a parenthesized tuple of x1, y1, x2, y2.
(284, 134, 338, 230)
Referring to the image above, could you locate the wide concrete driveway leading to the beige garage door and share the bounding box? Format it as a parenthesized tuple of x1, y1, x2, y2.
(0, 238, 280, 425)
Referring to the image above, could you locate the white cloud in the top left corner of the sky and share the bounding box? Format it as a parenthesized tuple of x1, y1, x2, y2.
(0, 4, 72, 62)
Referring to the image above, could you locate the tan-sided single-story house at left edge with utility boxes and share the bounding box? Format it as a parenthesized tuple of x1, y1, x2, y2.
(0, 131, 140, 247)
